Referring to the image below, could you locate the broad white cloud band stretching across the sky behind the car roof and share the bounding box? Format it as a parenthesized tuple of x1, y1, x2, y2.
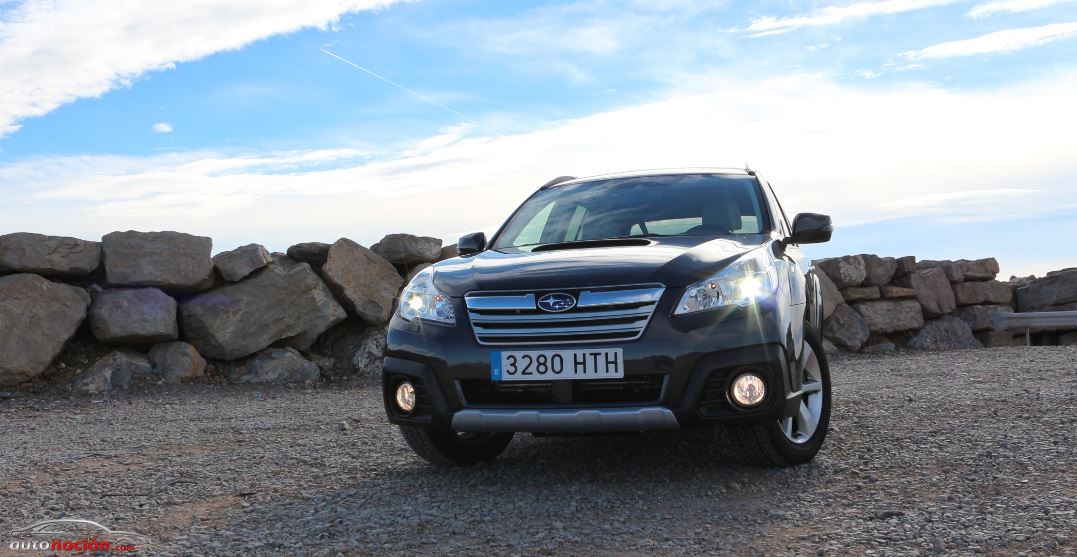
(0, 73, 1077, 256)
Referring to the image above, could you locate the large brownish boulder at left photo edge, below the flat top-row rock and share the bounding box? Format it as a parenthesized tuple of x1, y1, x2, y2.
(0, 274, 89, 385)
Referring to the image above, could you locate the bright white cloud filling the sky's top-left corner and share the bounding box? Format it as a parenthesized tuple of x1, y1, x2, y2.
(0, 0, 397, 137)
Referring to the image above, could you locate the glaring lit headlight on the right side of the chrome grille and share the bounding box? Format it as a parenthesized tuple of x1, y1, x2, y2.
(673, 249, 778, 315)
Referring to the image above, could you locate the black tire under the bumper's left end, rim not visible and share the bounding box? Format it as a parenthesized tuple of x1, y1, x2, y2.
(400, 426, 515, 467)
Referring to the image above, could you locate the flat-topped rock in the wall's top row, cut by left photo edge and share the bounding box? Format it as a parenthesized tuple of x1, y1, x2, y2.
(0, 232, 101, 277)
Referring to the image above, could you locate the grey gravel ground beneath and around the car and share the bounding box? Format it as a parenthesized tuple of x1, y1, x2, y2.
(0, 347, 1077, 555)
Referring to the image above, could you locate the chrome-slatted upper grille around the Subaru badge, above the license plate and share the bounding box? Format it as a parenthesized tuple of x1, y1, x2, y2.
(464, 284, 666, 345)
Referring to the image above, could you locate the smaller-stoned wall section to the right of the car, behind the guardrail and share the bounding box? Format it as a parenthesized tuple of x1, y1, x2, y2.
(812, 254, 1077, 352)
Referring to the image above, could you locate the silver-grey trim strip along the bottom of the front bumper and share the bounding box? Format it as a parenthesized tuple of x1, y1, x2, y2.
(452, 406, 681, 433)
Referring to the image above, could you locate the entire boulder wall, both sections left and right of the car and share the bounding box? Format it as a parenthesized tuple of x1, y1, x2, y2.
(0, 232, 1077, 393)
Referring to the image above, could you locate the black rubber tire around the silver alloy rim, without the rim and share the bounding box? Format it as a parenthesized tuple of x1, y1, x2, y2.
(721, 325, 830, 467)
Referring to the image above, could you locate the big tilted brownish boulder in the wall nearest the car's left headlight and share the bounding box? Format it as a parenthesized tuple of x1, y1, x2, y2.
(322, 238, 404, 324)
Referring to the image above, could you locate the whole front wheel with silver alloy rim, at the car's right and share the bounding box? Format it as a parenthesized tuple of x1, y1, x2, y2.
(728, 328, 830, 467)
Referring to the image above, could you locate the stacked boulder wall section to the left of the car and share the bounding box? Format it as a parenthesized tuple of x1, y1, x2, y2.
(0, 232, 456, 393)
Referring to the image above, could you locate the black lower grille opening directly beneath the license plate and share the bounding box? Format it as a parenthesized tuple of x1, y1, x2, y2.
(460, 374, 666, 405)
